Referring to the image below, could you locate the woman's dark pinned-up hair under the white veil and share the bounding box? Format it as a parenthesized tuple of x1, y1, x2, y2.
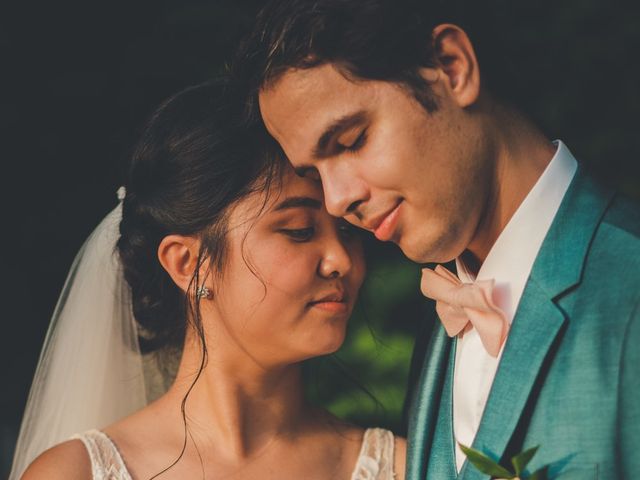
(117, 79, 280, 354)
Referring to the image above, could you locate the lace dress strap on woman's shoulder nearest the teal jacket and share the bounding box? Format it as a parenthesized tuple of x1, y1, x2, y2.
(351, 428, 395, 480)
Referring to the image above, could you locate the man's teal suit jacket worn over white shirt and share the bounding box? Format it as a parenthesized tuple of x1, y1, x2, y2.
(407, 168, 640, 480)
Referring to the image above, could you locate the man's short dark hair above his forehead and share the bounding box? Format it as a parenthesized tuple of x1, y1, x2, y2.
(232, 0, 482, 122)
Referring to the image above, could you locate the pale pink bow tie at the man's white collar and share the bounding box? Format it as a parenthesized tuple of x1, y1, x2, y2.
(420, 265, 509, 357)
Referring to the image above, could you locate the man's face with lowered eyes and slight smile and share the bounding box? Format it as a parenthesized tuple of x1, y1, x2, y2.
(260, 64, 491, 262)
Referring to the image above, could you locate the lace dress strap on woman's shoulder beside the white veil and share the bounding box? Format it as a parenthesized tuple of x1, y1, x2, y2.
(71, 430, 131, 480)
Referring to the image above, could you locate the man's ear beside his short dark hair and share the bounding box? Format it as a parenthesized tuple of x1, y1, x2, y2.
(431, 24, 480, 108)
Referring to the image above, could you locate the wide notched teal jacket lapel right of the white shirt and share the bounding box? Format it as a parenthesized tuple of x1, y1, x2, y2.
(460, 169, 613, 480)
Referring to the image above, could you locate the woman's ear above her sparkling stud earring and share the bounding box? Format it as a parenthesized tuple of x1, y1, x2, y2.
(158, 235, 200, 292)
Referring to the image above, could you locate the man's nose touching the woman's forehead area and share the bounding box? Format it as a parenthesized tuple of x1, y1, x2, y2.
(320, 165, 369, 220)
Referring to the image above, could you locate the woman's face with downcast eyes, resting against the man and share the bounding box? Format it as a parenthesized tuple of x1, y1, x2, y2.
(209, 168, 365, 366)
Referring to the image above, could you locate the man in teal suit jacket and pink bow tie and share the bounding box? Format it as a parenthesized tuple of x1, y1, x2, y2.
(236, 0, 640, 480)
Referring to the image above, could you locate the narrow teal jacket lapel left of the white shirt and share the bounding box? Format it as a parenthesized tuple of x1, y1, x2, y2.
(406, 325, 452, 480)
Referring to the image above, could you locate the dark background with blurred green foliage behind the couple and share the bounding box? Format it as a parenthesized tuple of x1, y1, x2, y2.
(0, 0, 640, 475)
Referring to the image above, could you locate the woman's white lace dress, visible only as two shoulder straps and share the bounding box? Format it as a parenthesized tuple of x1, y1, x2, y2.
(73, 428, 395, 480)
